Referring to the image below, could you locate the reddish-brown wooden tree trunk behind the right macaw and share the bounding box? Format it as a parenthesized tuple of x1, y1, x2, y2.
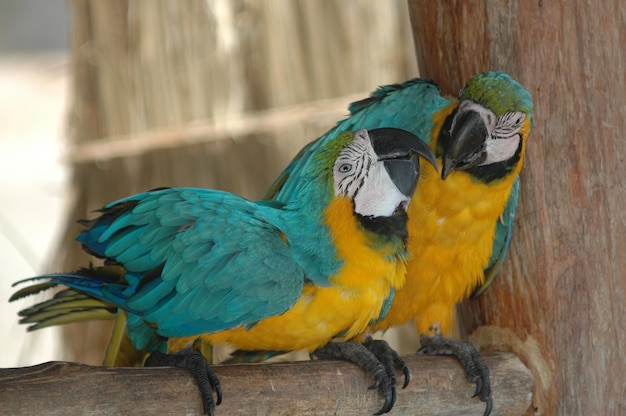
(409, 0, 626, 415)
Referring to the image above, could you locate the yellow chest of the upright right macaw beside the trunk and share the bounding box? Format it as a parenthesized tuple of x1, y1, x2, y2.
(374, 159, 515, 334)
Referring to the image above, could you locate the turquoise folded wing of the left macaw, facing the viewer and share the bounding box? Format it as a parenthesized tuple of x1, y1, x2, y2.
(23, 188, 305, 337)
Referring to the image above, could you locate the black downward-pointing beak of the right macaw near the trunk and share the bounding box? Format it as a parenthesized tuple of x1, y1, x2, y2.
(441, 110, 488, 179)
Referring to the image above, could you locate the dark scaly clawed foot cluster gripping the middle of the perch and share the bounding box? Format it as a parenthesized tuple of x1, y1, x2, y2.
(312, 340, 410, 415)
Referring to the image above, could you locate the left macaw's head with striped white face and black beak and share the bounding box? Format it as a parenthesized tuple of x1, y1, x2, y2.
(332, 128, 437, 217)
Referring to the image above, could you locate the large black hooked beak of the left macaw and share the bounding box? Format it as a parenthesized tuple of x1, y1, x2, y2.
(368, 128, 438, 197)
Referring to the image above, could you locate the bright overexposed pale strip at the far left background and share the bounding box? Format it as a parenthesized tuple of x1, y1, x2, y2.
(0, 0, 70, 367)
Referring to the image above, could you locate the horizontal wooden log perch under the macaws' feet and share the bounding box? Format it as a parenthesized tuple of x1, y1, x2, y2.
(0, 353, 533, 416)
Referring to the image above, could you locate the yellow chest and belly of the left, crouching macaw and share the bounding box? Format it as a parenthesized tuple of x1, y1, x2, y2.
(169, 199, 406, 351)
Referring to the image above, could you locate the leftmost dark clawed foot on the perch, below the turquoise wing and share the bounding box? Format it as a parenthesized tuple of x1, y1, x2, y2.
(145, 348, 222, 416)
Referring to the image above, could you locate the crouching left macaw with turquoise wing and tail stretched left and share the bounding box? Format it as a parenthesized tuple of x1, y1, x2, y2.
(11, 128, 437, 414)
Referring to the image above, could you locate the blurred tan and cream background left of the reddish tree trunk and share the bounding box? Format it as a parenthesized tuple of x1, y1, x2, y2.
(0, 0, 417, 367)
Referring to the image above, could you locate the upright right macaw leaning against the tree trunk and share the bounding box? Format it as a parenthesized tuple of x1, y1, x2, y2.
(260, 72, 533, 415)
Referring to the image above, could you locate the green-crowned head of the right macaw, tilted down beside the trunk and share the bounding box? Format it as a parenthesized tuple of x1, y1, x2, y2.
(438, 72, 533, 182)
